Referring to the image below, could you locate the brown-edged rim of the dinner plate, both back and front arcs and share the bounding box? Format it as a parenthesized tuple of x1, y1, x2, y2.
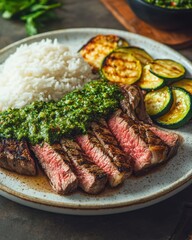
(0, 28, 192, 215)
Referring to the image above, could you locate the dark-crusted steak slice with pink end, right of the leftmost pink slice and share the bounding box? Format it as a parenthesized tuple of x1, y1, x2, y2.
(61, 138, 107, 194)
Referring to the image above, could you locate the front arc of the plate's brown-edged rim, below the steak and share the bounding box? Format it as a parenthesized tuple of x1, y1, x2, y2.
(0, 170, 192, 215)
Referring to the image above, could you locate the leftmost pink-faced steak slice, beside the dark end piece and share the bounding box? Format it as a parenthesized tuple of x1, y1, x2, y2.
(32, 143, 78, 194)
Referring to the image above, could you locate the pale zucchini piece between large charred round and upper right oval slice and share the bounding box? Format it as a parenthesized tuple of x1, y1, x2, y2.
(137, 64, 165, 91)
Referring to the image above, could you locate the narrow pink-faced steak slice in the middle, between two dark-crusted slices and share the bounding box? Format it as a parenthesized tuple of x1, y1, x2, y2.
(76, 131, 126, 187)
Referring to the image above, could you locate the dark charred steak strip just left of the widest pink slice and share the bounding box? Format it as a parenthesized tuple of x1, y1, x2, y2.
(91, 119, 132, 177)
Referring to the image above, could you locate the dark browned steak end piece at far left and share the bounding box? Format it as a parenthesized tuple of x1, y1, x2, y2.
(0, 139, 37, 176)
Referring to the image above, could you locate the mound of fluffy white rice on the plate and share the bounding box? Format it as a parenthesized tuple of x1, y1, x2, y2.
(0, 39, 94, 111)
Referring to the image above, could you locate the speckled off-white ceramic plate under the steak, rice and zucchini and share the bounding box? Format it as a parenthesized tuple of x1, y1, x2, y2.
(0, 28, 192, 215)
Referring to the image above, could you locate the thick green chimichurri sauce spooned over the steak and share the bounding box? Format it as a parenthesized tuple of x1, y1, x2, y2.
(0, 80, 122, 144)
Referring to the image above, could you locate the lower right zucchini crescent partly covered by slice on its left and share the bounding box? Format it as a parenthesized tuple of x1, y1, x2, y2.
(155, 87, 192, 129)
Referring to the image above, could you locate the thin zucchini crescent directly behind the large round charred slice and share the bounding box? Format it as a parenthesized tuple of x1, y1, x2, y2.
(115, 46, 153, 66)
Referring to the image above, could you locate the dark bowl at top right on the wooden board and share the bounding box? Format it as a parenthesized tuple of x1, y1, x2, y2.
(126, 0, 192, 30)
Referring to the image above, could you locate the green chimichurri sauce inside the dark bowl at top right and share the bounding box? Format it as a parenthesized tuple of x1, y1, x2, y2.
(145, 0, 192, 9)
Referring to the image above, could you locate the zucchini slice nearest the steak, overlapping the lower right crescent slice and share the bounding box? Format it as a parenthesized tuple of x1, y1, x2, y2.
(144, 86, 173, 118)
